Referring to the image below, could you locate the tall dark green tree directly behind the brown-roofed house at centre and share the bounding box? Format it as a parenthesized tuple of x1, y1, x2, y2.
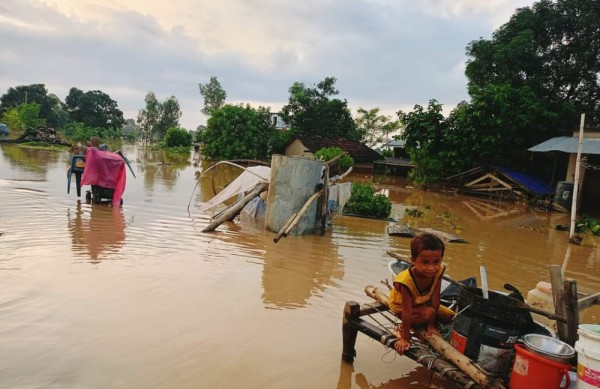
(281, 77, 361, 141)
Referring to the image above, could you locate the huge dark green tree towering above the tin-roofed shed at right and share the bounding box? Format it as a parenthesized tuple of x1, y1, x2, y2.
(465, 0, 600, 144)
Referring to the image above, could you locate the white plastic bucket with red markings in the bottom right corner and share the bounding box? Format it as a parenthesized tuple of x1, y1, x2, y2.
(575, 324, 600, 389)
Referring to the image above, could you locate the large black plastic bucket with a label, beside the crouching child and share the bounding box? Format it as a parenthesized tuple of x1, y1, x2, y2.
(450, 288, 529, 376)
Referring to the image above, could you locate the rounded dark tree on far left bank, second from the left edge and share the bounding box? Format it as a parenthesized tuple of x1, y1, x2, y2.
(65, 88, 125, 130)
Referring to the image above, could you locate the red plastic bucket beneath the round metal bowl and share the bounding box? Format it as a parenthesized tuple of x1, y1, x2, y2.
(508, 344, 571, 389)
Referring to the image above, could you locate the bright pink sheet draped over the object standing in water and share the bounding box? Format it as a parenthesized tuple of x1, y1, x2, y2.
(81, 147, 127, 205)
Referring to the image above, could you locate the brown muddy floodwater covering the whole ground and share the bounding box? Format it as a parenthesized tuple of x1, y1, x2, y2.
(0, 145, 600, 389)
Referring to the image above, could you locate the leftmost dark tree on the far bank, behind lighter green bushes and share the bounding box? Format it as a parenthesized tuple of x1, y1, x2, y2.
(0, 84, 64, 128)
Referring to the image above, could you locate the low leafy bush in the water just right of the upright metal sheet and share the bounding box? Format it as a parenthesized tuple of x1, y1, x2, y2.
(344, 182, 392, 218)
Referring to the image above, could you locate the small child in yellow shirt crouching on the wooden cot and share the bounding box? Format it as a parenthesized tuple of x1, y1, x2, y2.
(389, 233, 454, 354)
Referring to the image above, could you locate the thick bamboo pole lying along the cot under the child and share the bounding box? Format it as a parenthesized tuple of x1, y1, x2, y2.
(365, 285, 505, 389)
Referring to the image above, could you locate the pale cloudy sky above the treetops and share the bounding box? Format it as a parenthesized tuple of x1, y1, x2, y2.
(0, 0, 534, 130)
